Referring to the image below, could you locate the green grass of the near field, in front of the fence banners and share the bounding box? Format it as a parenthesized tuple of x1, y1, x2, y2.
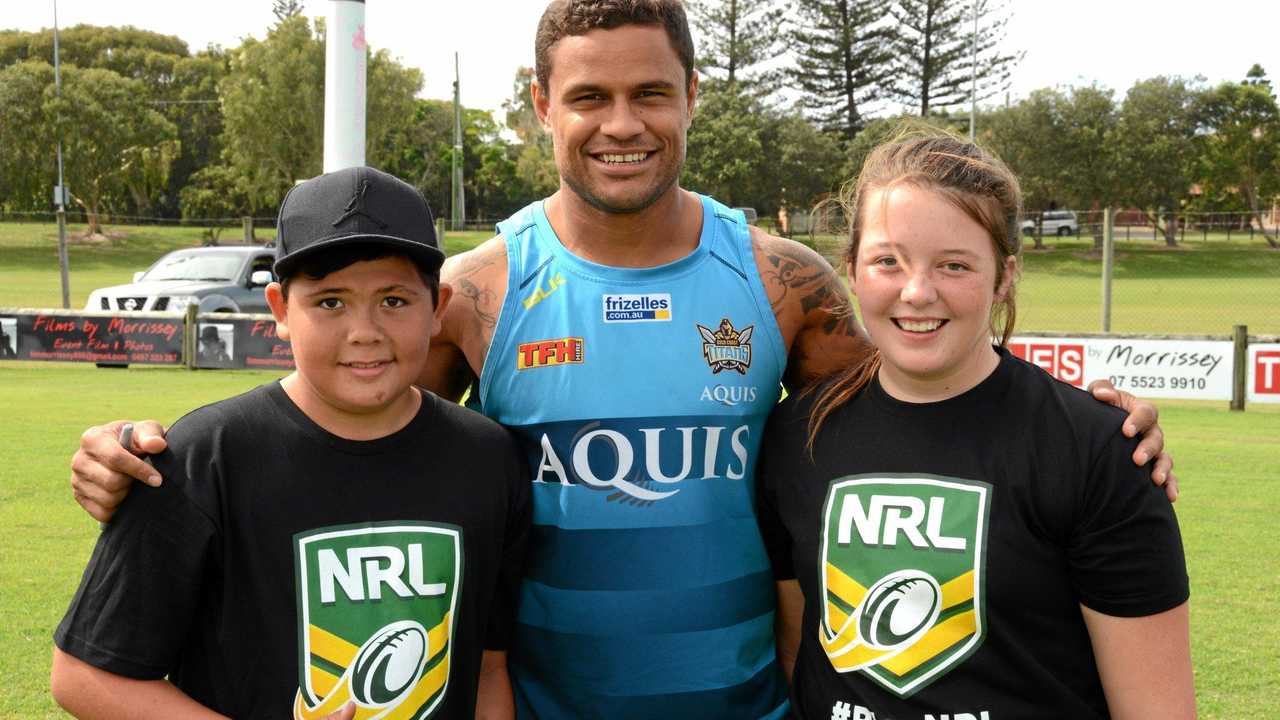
(0, 363, 1280, 720)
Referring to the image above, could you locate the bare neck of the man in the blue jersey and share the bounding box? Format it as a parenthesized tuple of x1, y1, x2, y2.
(544, 186, 703, 268)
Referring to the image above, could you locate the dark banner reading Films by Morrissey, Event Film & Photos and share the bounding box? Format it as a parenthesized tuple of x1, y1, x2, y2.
(0, 313, 183, 365)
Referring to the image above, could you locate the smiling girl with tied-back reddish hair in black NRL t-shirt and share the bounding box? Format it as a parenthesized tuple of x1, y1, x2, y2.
(756, 135, 1196, 720)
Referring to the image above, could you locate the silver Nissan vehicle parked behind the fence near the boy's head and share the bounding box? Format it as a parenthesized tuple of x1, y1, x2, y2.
(84, 245, 275, 313)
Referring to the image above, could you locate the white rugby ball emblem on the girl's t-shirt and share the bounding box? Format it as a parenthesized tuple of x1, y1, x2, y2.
(856, 570, 942, 650)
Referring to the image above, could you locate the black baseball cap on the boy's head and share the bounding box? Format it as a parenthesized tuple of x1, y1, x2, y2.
(275, 167, 444, 278)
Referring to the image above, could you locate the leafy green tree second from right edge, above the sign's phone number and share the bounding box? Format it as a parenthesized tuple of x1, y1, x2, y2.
(1114, 77, 1198, 247)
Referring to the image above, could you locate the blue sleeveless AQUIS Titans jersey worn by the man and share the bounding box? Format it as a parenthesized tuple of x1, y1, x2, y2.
(479, 197, 787, 720)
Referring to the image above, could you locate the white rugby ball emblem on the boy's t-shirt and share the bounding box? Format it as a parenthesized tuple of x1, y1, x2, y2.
(351, 620, 431, 707)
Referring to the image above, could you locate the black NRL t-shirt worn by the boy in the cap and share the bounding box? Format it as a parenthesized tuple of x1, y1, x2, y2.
(54, 383, 530, 719)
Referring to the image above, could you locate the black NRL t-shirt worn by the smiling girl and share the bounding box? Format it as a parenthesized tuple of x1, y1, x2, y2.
(756, 350, 1188, 720)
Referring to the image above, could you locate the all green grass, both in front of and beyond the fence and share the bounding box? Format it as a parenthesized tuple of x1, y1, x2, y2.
(0, 224, 1280, 720)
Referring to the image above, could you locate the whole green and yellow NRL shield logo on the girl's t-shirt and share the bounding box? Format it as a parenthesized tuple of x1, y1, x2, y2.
(818, 474, 991, 697)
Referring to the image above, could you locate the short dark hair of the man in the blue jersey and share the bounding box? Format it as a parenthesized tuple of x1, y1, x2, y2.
(534, 0, 694, 92)
